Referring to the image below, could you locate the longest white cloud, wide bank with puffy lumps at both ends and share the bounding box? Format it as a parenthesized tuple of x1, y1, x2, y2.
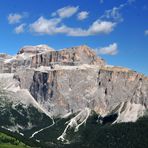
(30, 17, 116, 36)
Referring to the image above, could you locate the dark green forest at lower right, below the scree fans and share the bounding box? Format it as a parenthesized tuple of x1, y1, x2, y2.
(66, 117, 148, 148)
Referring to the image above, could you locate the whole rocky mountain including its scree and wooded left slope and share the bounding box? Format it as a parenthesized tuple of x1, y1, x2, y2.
(0, 45, 148, 145)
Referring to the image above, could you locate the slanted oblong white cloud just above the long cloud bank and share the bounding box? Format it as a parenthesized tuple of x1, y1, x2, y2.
(52, 6, 79, 18)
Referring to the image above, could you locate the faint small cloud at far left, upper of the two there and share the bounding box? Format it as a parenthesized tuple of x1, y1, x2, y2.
(8, 12, 28, 24)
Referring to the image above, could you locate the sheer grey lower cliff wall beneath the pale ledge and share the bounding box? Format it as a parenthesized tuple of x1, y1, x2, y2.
(16, 65, 148, 121)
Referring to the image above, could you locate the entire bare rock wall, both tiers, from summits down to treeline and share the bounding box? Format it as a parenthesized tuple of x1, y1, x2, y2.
(1, 46, 148, 122)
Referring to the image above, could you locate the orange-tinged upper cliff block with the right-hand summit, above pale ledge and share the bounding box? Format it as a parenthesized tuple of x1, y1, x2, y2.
(28, 46, 105, 67)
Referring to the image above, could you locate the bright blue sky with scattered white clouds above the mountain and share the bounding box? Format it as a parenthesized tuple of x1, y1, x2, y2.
(0, 0, 148, 75)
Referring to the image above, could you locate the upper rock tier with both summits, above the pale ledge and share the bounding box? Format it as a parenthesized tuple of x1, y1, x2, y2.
(1, 45, 105, 73)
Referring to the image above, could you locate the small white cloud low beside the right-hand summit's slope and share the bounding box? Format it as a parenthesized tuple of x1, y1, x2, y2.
(98, 43, 118, 55)
